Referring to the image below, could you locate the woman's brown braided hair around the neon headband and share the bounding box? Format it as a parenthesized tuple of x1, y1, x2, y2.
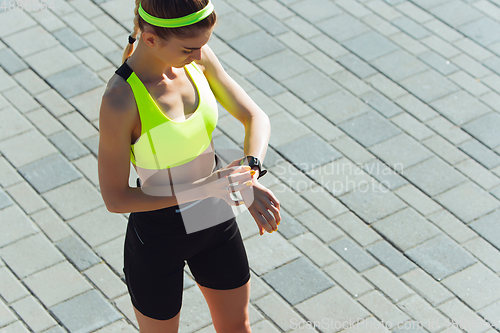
(122, 0, 217, 63)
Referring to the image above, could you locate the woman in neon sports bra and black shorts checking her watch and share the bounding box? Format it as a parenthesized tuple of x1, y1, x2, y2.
(98, 0, 281, 333)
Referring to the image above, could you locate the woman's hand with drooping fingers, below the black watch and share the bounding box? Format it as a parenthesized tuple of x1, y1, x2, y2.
(238, 175, 281, 235)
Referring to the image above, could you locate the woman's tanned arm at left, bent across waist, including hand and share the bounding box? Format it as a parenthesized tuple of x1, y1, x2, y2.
(97, 79, 254, 213)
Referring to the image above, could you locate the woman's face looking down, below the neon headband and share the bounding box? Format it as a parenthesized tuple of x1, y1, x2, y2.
(157, 27, 214, 68)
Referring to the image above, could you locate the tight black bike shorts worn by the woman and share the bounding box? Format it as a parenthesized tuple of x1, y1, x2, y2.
(123, 156, 250, 320)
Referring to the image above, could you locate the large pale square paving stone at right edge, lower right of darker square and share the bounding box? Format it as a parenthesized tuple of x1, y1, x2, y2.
(442, 263, 500, 311)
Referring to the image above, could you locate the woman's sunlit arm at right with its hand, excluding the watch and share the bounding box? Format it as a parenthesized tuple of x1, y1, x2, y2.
(196, 45, 281, 234)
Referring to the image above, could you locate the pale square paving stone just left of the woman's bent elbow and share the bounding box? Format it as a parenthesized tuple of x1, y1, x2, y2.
(42, 179, 104, 220)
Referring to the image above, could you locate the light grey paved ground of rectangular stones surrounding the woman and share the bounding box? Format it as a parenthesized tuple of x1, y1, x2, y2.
(0, 0, 500, 333)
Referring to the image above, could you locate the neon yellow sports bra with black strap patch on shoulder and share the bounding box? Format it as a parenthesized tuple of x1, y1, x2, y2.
(115, 61, 218, 170)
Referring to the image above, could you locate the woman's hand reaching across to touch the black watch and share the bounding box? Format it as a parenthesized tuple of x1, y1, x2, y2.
(200, 165, 255, 206)
